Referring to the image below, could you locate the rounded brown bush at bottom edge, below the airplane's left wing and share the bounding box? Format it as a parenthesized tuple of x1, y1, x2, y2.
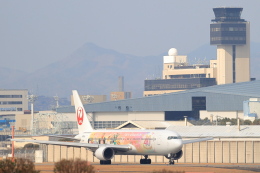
(54, 159, 95, 173)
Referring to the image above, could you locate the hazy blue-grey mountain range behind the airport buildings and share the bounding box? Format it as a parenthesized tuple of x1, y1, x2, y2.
(0, 43, 260, 100)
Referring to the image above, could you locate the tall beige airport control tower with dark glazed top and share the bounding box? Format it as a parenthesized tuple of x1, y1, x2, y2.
(210, 7, 250, 84)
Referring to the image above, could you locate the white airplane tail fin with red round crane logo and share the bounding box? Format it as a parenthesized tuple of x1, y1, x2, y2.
(72, 90, 93, 134)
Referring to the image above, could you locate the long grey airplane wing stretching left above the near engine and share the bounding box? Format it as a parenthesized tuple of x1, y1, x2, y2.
(11, 139, 132, 152)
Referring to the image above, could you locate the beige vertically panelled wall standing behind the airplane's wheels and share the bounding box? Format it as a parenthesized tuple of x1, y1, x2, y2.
(43, 141, 260, 163)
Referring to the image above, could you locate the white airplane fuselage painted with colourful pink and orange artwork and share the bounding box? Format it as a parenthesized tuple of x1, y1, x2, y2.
(78, 130, 183, 155)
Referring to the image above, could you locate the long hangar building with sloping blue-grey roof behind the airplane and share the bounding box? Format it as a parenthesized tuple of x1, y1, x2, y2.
(57, 80, 260, 128)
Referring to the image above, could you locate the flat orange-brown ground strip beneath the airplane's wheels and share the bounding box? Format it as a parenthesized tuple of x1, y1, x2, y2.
(35, 163, 260, 173)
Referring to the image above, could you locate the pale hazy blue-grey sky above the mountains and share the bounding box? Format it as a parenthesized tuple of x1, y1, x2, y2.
(0, 0, 260, 72)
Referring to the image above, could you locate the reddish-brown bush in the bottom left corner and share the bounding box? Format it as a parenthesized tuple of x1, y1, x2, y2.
(0, 158, 40, 173)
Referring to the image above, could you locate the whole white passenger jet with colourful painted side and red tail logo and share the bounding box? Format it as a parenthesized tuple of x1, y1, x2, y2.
(12, 90, 213, 165)
